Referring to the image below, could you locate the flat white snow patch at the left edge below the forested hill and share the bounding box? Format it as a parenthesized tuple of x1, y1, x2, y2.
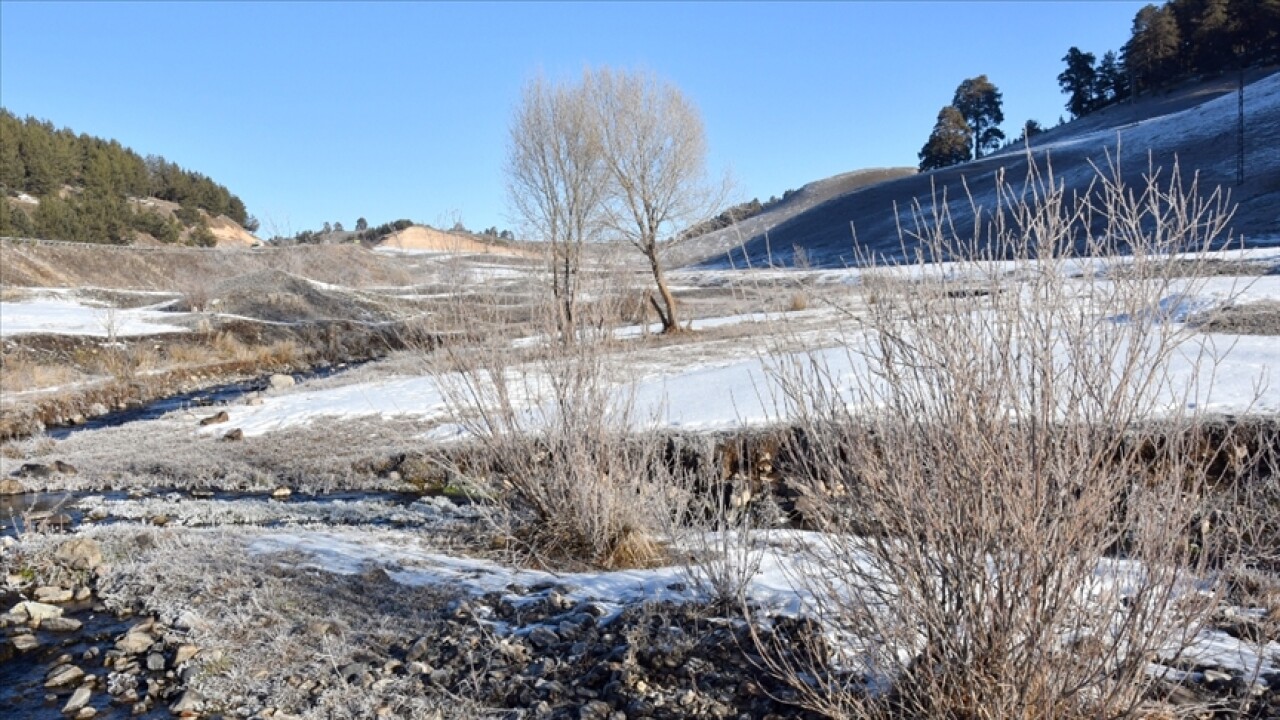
(0, 297, 187, 337)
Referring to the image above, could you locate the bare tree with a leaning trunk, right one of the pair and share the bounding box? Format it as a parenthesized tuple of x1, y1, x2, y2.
(588, 68, 722, 333)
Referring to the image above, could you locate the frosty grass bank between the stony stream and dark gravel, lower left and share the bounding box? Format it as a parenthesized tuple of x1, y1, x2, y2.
(90, 525, 499, 720)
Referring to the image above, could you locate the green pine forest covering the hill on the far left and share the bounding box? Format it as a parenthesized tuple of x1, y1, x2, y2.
(0, 109, 257, 245)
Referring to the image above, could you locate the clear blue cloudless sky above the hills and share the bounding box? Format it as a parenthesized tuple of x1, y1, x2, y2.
(0, 1, 1144, 234)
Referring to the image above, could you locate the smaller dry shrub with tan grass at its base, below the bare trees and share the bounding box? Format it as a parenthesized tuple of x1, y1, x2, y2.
(438, 333, 664, 568)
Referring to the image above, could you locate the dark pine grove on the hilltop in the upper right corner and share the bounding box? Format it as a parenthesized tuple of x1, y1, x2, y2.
(1057, 0, 1280, 117)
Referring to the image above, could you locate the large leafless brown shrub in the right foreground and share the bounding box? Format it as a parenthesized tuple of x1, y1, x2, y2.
(760, 159, 1249, 719)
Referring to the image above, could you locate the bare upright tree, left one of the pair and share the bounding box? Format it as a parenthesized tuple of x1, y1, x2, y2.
(507, 76, 607, 341)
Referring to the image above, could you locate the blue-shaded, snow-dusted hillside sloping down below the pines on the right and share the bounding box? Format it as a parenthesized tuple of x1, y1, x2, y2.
(701, 68, 1280, 268)
